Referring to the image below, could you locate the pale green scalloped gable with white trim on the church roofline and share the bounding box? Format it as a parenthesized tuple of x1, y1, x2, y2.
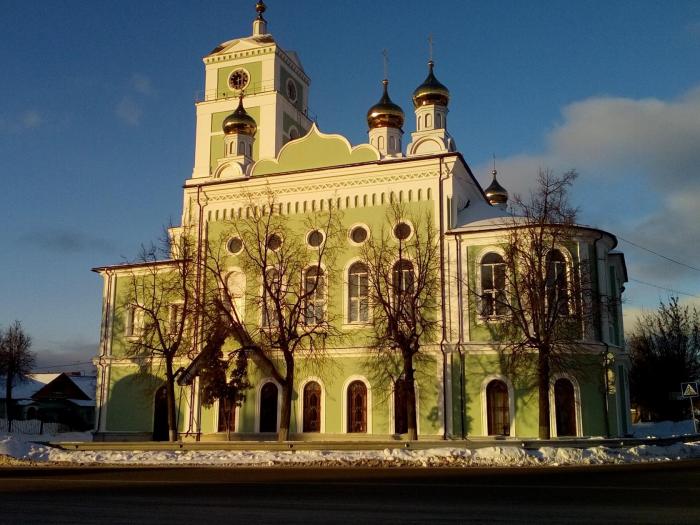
(251, 124, 380, 177)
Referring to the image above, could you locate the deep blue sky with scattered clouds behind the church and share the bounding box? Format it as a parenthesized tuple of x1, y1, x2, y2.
(0, 0, 700, 369)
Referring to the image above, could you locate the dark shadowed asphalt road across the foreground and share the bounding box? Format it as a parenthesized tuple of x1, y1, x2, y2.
(0, 461, 700, 525)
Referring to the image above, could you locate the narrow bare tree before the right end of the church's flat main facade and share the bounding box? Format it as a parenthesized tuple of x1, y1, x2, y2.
(360, 202, 440, 440)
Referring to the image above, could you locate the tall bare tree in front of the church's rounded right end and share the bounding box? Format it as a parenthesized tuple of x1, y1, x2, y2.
(471, 170, 595, 439)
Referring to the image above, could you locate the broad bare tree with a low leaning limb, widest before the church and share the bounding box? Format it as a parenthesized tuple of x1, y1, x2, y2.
(206, 192, 339, 441)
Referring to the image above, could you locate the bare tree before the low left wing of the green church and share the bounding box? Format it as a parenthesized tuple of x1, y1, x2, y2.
(125, 228, 198, 441)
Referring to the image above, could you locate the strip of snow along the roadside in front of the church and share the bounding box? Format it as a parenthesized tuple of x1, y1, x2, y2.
(0, 421, 700, 467)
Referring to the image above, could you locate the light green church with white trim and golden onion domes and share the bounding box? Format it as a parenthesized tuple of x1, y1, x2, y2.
(94, 1, 631, 441)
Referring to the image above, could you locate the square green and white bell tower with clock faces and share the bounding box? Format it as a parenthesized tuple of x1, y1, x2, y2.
(192, 0, 311, 179)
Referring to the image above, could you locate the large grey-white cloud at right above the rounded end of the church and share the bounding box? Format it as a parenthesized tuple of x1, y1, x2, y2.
(477, 86, 700, 291)
